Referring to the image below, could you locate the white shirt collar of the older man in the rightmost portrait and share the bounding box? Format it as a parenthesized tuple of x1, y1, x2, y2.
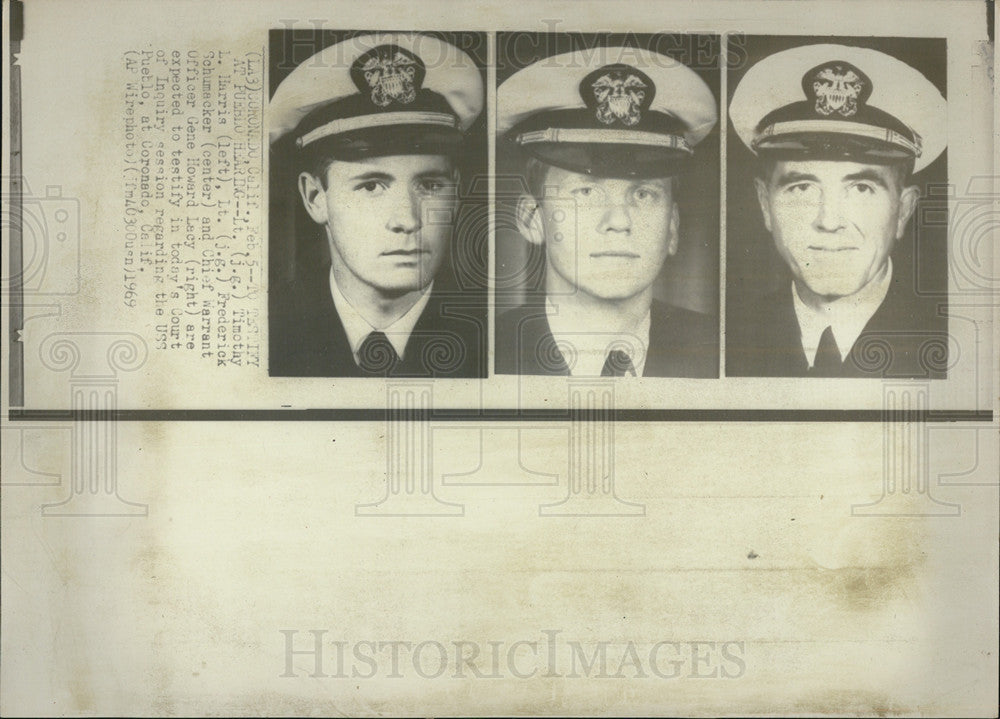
(792, 258, 892, 368)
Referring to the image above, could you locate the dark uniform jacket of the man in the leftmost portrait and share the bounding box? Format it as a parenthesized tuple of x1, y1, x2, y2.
(269, 262, 486, 377)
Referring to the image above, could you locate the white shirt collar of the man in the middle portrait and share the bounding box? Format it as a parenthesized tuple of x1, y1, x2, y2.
(545, 297, 650, 377)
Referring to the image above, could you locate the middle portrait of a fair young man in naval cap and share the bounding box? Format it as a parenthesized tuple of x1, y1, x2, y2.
(495, 35, 719, 377)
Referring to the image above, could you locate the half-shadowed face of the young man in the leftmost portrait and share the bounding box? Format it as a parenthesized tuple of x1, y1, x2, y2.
(299, 155, 457, 297)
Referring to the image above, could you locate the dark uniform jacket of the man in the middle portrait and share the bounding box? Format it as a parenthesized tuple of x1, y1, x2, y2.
(496, 300, 719, 377)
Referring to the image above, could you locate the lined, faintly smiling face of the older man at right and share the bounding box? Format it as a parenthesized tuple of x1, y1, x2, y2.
(756, 160, 918, 301)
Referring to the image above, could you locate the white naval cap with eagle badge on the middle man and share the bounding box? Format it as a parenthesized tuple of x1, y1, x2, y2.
(497, 47, 718, 177)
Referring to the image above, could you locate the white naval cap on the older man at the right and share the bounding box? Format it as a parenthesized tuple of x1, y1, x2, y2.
(729, 45, 948, 171)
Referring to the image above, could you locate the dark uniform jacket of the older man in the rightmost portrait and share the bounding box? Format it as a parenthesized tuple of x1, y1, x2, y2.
(726, 263, 948, 379)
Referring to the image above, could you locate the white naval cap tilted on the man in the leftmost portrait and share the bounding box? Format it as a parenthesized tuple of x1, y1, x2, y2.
(268, 33, 483, 156)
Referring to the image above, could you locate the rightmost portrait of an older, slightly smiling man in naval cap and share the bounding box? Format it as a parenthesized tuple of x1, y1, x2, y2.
(726, 41, 947, 378)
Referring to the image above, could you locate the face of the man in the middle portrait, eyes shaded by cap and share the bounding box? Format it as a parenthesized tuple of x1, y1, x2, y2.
(538, 167, 678, 300)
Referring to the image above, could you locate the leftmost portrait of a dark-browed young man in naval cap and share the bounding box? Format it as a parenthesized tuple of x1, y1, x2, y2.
(268, 33, 486, 377)
